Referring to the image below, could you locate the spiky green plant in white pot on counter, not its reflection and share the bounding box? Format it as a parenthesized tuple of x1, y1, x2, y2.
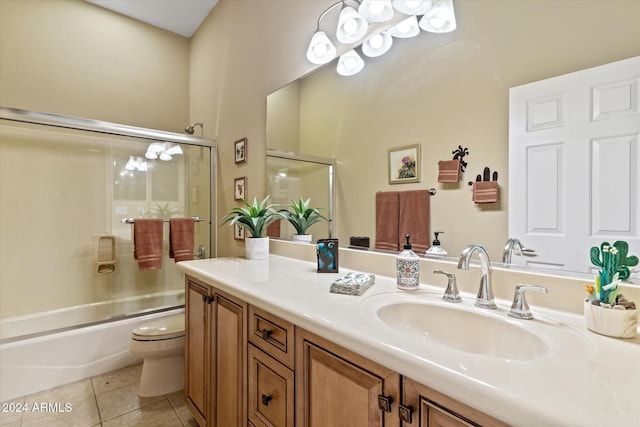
(222, 196, 281, 259)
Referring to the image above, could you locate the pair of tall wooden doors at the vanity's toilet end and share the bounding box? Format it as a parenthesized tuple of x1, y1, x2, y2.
(185, 277, 247, 427)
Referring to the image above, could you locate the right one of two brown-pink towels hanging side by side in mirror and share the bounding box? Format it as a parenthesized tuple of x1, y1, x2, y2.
(398, 190, 431, 253)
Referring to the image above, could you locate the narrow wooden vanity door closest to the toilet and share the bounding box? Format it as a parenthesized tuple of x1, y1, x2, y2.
(185, 279, 209, 426)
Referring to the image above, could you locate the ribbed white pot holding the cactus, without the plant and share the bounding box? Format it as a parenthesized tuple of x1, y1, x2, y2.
(584, 298, 638, 338)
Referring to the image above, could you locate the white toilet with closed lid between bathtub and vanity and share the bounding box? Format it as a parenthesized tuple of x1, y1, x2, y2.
(129, 313, 184, 397)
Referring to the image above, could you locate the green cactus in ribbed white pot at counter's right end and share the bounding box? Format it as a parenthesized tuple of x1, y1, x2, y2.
(584, 240, 638, 338)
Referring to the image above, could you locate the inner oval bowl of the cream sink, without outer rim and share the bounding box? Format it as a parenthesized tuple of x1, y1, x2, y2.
(377, 301, 549, 359)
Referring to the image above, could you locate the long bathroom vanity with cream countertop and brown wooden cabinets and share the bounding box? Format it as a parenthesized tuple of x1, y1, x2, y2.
(178, 245, 640, 427)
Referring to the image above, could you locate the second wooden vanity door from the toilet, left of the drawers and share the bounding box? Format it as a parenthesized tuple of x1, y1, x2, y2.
(211, 292, 247, 427)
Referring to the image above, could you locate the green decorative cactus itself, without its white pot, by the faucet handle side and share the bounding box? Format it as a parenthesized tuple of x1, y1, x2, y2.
(590, 240, 638, 305)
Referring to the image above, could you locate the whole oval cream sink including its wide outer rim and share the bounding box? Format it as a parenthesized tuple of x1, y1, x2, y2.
(360, 291, 595, 363)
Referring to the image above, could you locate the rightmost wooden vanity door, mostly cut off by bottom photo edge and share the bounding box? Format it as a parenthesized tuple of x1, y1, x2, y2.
(399, 377, 506, 427)
